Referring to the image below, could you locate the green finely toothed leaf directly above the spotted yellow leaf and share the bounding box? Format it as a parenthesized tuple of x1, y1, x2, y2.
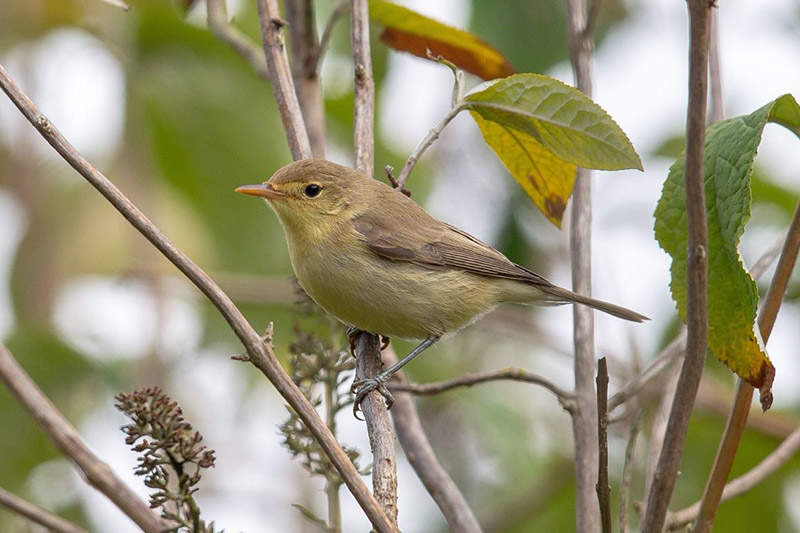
(464, 74, 642, 170)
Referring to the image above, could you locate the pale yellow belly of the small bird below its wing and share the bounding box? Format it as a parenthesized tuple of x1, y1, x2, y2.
(293, 250, 496, 339)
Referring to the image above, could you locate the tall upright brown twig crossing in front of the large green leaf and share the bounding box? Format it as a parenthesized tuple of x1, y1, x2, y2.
(642, 0, 711, 531)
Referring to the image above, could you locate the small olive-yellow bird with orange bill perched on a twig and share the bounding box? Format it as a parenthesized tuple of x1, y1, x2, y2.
(236, 159, 648, 416)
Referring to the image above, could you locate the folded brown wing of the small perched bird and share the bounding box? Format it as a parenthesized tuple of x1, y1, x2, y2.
(354, 213, 552, 286)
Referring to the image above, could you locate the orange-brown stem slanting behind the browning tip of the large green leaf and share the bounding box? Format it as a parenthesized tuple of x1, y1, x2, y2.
(694, 193, 800, 533)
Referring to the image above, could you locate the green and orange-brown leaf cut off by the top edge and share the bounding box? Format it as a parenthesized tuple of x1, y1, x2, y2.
(369, 0, 514, 80)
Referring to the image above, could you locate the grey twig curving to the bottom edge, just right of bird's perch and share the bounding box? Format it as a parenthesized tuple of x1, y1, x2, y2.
(384, 346, 481, 533)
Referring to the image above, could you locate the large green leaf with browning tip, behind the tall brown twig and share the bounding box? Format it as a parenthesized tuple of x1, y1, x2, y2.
(655, 94, 800, 405)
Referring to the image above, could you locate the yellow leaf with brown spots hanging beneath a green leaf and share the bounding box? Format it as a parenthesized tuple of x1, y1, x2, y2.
(470, 111, 577, 227)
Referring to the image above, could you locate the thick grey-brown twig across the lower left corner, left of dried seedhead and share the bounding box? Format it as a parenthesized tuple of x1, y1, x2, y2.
(0, 342, 167, 533)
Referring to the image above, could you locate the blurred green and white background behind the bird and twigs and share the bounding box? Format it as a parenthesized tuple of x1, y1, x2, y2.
(0, 0, 800, 533)
